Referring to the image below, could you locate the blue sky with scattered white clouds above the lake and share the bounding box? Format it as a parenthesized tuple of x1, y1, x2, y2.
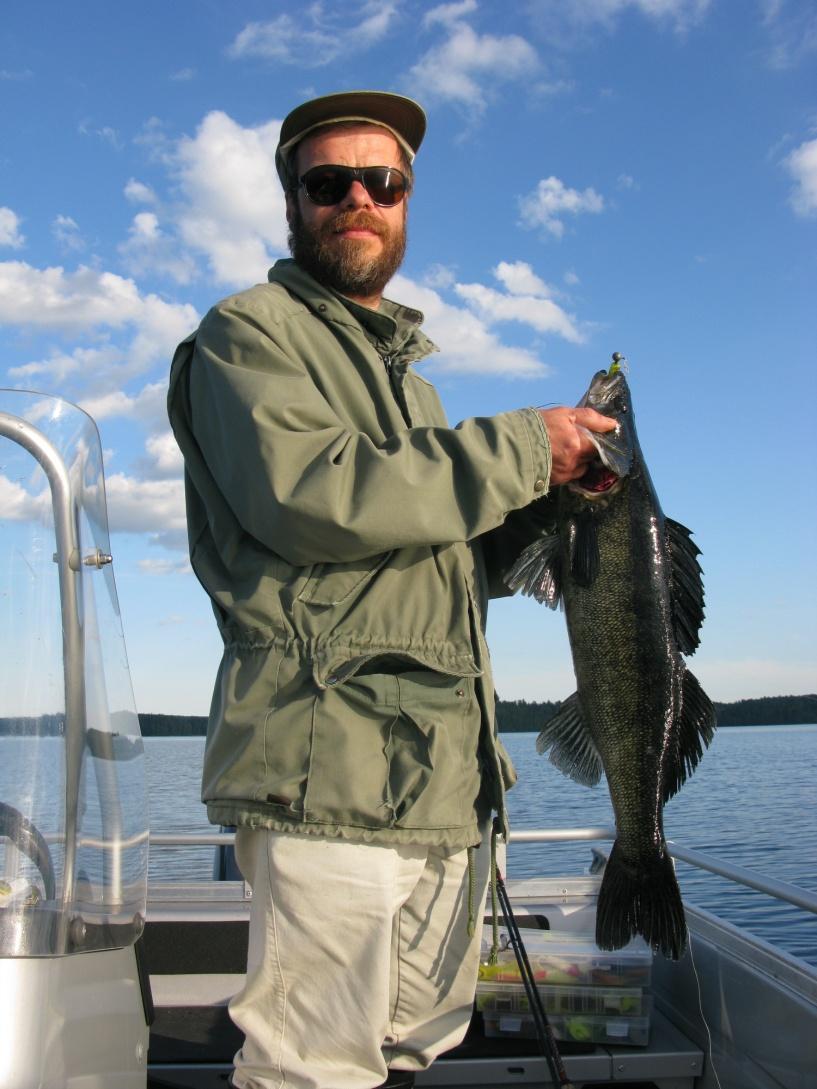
(0, 0, 817, 714)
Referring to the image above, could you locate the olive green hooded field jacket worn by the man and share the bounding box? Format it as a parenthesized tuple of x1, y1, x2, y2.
(168, 260, 550, 846)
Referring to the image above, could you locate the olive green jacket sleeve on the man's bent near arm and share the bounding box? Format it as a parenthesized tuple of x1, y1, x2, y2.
(186, 307, 550, 565)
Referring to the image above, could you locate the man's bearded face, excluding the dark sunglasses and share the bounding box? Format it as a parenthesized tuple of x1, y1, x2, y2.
(286, 124, 406, 306)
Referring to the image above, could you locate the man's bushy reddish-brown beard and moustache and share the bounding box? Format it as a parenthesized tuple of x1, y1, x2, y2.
(289, 205, 405, 298)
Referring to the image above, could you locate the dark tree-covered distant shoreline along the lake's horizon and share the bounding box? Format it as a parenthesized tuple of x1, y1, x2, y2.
(0, 694, 817, 737)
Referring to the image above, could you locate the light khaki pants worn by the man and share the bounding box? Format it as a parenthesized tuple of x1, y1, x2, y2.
(230, 829, 490, 1089)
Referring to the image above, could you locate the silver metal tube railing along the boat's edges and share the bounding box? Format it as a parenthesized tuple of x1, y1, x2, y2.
(150, 828, 817, 915)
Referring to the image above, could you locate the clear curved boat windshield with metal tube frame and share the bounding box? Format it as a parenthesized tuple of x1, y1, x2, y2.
(0, 390, 148, 957)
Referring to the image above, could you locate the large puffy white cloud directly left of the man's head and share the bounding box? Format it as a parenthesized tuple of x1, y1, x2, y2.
(174, 111, 286, 285)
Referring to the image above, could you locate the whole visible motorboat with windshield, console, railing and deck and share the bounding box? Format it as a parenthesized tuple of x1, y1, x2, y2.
(0, 391, 817, 1089)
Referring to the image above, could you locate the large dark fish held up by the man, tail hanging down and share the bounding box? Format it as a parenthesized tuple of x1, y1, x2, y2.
(505, 353, 716, 959)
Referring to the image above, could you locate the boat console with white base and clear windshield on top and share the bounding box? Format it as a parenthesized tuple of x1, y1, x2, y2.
(0, 391, 149, 1089)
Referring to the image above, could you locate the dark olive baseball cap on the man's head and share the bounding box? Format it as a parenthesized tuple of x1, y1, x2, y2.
(276, 90, 426, 188)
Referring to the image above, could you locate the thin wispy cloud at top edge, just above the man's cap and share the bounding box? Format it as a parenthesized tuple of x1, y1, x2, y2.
(228, 0, 398, 68)
